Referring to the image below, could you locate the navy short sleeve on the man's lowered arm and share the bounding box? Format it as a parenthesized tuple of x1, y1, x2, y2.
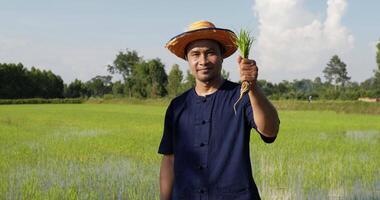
(158, 103, 174, 155)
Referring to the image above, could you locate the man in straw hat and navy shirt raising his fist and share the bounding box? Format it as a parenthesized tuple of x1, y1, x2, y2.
(158, 21, 279, 200)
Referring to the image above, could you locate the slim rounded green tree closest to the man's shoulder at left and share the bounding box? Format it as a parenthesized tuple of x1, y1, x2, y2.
(168, 64, 183, 97)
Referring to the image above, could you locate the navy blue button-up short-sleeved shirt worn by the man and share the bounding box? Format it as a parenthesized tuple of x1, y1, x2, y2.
(158, 80, 275, 200)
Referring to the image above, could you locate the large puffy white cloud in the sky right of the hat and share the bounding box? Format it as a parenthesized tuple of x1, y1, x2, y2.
(254, 0, 354, 81)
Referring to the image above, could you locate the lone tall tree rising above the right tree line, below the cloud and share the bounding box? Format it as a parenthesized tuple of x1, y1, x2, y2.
(323, 55, 351, 87)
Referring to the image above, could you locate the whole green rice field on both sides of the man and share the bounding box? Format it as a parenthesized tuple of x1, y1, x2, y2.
(0, 104, 380, 200)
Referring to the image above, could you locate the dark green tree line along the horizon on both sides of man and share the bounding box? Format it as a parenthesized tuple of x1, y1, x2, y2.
(0, 41, 380, 100)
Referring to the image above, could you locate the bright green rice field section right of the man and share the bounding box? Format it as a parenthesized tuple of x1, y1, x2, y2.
(252, 111, 380, 199)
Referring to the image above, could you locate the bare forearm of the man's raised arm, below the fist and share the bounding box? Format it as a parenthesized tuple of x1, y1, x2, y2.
(248, 84, 280, 137)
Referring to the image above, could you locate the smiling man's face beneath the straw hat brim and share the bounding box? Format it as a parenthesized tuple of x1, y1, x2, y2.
(186, 40, 223, 82)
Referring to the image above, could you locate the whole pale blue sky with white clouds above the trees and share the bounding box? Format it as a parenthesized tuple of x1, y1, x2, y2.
(0, 0, 380, 83)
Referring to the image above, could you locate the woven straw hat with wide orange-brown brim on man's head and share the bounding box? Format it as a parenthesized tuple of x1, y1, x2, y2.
(165, 21, 236, 59)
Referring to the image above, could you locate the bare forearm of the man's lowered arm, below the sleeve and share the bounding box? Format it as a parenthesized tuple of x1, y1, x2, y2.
(160, 155, 174, 200)
